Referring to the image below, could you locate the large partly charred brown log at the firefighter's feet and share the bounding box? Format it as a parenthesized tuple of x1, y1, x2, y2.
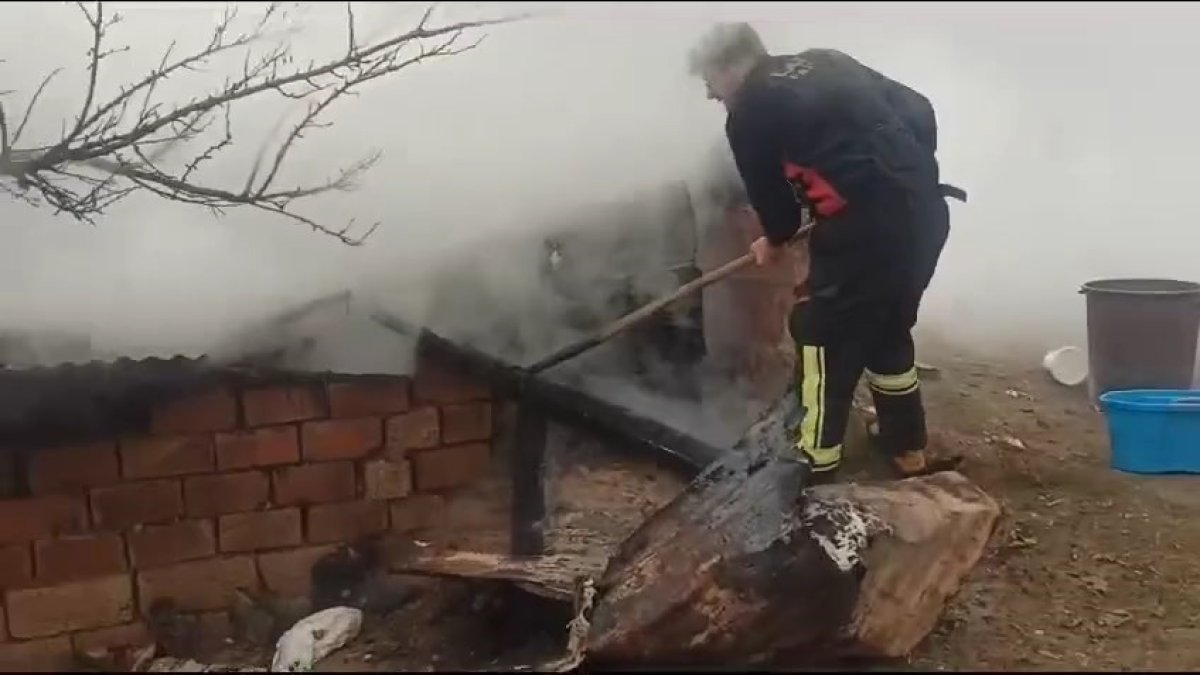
(587, 456, 1000, 667)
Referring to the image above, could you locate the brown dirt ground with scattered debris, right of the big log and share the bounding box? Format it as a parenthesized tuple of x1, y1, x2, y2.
(912, 338, 1200, 670)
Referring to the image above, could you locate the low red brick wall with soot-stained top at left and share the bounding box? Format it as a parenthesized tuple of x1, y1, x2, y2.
(0, 355, 508, 670)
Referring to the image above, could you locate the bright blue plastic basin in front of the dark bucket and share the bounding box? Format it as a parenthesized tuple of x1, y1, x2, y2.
(1100, 389, 1200, 473)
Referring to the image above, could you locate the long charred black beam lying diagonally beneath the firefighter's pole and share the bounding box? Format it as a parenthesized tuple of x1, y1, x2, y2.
(373, 311, 726, 476)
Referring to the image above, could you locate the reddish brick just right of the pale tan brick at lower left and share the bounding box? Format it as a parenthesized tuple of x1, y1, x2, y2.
(138, 556, 258, 613)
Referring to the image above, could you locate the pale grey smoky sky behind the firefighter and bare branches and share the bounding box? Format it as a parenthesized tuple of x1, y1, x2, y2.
(0, 2, 1200, 360)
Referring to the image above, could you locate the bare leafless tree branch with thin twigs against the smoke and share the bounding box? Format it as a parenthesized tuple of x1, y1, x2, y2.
(0, 2, 521, 245)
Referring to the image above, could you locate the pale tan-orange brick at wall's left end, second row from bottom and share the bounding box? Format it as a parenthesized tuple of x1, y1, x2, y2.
(7, 574, 133, 639)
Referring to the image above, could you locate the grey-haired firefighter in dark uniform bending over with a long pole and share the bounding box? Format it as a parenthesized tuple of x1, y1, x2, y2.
(690, 23, 958, 480)
